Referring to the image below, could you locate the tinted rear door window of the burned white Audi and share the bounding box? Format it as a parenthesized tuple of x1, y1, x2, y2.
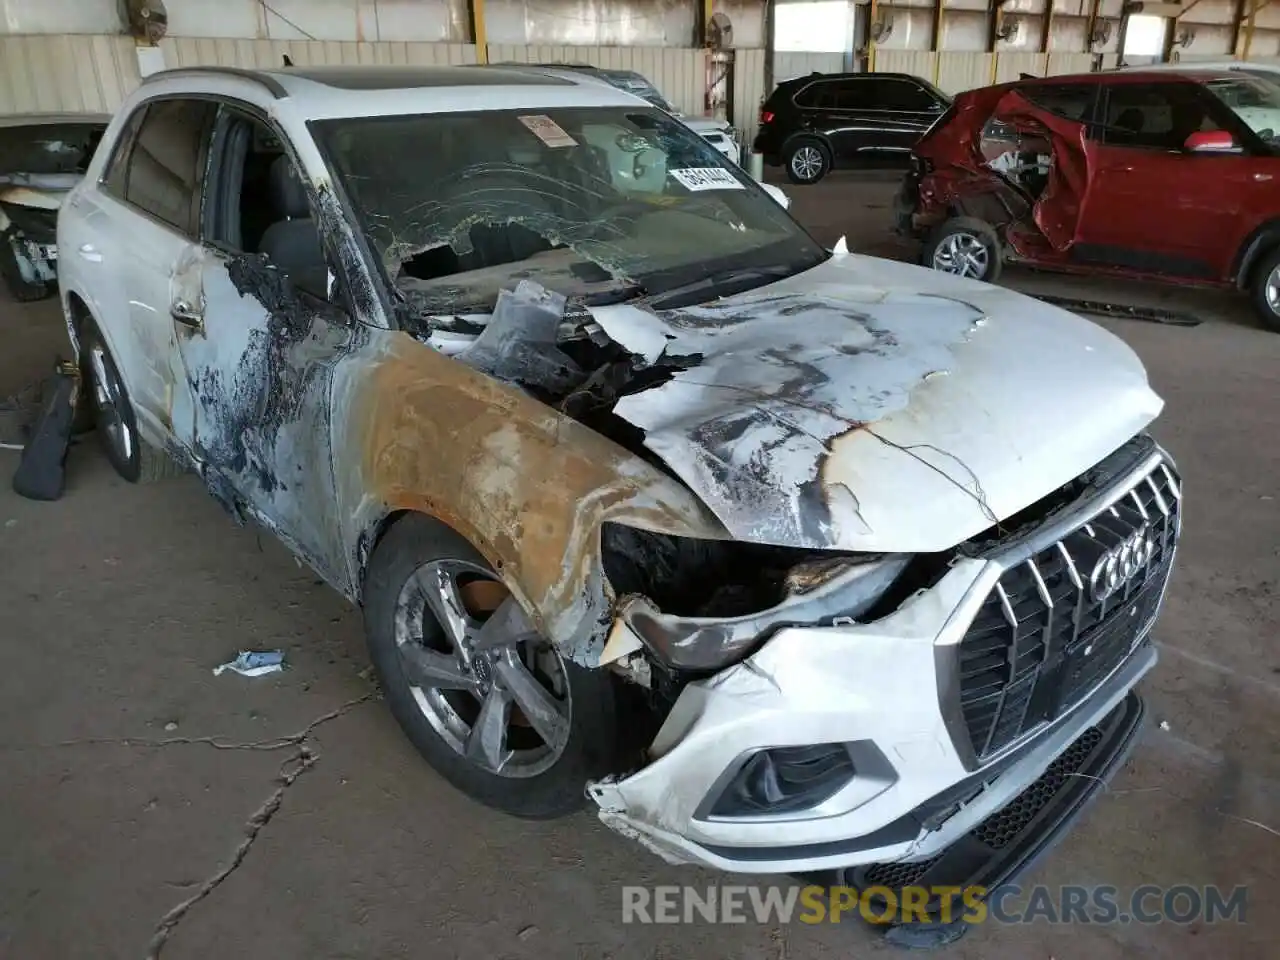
(124, 100, 218, 234)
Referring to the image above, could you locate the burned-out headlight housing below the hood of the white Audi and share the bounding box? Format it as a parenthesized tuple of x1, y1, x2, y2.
(602, 524, 911, 672)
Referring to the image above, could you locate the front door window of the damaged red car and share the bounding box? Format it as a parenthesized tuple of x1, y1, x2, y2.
(1102, 83, 1222, 150)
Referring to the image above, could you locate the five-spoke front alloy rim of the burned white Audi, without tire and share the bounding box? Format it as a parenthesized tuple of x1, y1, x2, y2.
(396, 559, 571, 777)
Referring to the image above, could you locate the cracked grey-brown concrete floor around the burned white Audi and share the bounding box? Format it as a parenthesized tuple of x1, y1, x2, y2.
(0, 175, 1280, 960)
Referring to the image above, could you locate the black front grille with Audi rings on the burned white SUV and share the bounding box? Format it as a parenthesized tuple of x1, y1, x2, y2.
(959, 462, 1181, 760)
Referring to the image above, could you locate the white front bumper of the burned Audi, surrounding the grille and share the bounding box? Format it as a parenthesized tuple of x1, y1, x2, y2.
(589, 440, 1180, 873)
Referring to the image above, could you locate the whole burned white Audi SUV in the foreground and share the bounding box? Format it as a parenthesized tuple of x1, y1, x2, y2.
(58, 67, 1180, 942)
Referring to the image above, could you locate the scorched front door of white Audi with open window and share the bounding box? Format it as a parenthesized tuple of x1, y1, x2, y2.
(173, 106, 353, 585)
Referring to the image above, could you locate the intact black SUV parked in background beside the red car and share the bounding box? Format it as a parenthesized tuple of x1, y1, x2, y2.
(755, 73, 951, 183)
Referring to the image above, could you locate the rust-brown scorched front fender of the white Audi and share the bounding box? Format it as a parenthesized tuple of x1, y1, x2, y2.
(334, 332, 726, 666)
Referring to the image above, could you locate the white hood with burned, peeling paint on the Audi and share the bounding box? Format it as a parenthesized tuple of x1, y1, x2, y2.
(593, 255, 1161, 552)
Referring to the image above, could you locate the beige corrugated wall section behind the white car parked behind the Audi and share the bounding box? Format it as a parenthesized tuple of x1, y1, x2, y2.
(489, 44, 706, 116)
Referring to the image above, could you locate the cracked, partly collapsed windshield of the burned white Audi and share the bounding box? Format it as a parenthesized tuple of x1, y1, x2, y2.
(314, 108, 824, 316)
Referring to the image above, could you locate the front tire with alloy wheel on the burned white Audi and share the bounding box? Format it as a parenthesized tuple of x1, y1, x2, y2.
(364, 516, 618, 819)
